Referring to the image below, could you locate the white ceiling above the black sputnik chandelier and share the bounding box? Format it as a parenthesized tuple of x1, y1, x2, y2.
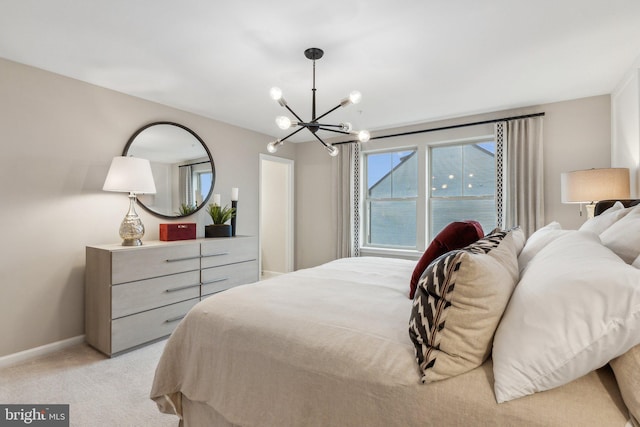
(0, 0, 640, 145)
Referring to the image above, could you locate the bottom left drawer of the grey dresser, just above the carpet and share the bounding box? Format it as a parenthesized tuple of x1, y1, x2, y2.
(111, 298, 200, 355)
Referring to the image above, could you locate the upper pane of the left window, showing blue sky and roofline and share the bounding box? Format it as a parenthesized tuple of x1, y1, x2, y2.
(367, 151, 418, 199)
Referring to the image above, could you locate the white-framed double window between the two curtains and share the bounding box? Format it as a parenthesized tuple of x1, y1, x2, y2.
(360, 137, 497, 252)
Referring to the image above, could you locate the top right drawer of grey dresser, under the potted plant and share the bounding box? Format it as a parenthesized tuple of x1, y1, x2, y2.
(201, 237, 258, 268)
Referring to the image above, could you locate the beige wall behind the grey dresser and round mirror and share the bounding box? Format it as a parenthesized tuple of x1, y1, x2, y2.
(0, 59, 294, 357)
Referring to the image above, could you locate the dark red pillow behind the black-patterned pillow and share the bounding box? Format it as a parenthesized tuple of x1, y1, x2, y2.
(409, 220, 484, 299)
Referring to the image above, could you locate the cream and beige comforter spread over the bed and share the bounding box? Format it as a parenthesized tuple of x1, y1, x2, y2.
(151, 258, 626, 427)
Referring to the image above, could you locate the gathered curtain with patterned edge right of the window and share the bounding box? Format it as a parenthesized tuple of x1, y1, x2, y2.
(495, 117, 545, 236)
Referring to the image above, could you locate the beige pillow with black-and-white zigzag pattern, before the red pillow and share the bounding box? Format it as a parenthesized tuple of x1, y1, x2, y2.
(409, 229, 522, 383)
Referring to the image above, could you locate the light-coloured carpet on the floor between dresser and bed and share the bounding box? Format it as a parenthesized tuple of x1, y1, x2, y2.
(0, 341, 178, 427)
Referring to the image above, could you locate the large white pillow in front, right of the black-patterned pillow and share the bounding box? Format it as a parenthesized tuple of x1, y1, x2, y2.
(493, 231, 640, 403)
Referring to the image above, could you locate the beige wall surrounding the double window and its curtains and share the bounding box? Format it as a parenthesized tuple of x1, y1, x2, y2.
(296, 95, 611, 268)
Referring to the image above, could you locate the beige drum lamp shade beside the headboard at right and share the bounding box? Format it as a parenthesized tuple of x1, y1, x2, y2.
(561, 168, 630, 203)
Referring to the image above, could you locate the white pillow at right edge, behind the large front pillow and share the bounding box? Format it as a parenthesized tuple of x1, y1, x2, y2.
(600, 206, 640, 264)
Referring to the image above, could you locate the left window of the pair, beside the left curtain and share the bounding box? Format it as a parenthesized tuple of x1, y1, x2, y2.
(364, 150, 418, 248)
